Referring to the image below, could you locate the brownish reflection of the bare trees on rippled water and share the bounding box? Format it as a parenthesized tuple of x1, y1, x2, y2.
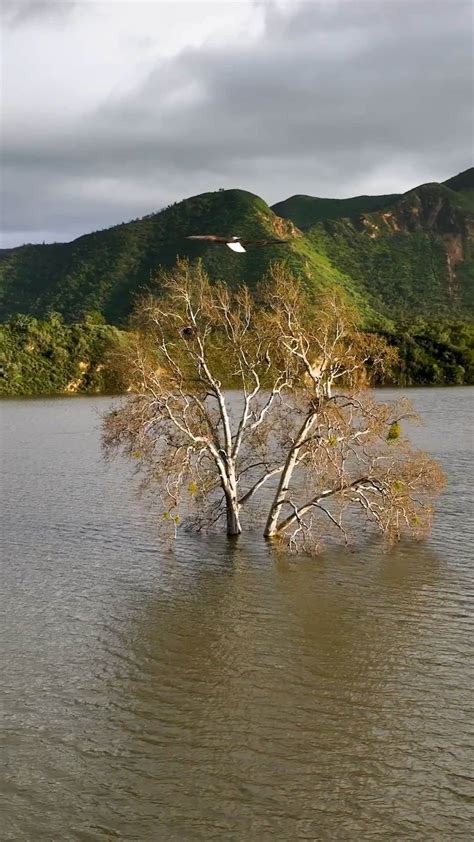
(74, 542, 468, 839)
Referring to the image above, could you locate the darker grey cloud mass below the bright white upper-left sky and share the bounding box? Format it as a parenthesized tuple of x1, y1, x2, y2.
(4, 0, 472, 246)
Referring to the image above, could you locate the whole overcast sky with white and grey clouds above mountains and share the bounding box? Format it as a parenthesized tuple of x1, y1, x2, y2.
(1, 0, 473, 246)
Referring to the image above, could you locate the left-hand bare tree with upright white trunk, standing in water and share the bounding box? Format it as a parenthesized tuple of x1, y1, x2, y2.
(104, 261, 290, 536)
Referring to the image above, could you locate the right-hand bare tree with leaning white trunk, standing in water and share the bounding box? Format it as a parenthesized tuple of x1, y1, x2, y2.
(264, 266, 444, 548)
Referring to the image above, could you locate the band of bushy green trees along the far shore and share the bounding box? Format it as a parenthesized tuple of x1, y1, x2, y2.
(0, 306, 474, 397)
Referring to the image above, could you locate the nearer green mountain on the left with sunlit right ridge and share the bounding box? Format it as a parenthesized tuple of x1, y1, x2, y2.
(0, 190, 362, 323)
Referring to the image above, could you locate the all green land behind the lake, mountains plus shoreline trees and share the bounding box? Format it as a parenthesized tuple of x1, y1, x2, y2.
(0, 169, 474, 395)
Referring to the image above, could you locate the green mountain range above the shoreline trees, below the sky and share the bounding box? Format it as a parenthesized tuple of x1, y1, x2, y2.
(0, 169, 474, 327)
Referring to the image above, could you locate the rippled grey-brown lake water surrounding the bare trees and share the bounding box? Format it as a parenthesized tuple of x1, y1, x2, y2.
(0, 388, 474, 842)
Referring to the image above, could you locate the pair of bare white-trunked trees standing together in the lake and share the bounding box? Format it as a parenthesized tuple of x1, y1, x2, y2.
(104, 261, 443, 548)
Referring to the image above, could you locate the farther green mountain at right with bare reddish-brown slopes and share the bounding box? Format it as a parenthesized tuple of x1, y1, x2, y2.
(305, 184, 474, 319)
